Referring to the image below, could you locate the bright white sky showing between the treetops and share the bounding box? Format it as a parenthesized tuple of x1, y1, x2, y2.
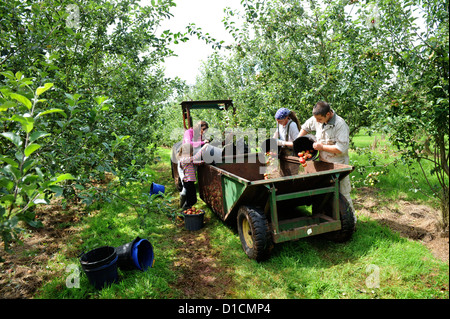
(155, 0, 246, 85)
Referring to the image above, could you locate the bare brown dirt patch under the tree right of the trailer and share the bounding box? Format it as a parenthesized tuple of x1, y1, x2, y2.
(353, 188, 449, 263)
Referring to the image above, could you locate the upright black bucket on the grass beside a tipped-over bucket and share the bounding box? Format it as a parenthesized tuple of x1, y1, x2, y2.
(80, 246, 118, 289)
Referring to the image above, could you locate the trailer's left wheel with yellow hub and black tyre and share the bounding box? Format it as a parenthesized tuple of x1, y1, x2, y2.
(237, 206, 273, 261)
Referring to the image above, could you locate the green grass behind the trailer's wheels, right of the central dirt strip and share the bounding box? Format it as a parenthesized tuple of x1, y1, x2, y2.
(209, 218, 448, 299)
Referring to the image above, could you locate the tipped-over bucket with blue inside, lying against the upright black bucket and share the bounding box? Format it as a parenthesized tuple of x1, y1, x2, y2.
(116, 237, 154, 271)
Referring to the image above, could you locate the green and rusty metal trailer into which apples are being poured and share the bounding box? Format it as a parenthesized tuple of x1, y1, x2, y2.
(198, 154, 355, 261)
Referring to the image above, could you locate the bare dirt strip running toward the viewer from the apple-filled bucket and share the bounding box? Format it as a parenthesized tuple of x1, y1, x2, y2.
(173, 218, 232, 299)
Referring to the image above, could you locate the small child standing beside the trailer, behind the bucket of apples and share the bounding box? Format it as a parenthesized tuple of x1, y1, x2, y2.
(178, 143, 206, 209)
